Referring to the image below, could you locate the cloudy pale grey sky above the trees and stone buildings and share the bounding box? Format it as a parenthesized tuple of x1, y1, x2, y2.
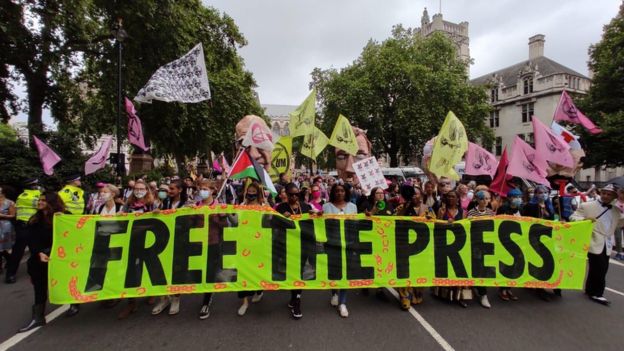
(203, 0, 621, 105)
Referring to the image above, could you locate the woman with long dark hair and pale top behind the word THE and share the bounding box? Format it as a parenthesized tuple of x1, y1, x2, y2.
(323, 184, 357, 318)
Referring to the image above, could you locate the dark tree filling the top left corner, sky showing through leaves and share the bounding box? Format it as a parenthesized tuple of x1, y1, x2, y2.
(0, 0, 109, 135)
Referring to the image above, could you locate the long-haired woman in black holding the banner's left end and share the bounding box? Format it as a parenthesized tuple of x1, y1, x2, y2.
(18, 191, 67, 333)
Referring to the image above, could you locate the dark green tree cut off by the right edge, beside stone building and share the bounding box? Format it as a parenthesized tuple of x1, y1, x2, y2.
(579, 4, 624, 167)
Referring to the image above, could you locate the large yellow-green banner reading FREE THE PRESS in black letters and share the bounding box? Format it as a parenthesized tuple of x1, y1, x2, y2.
(49, 205, 592, 304)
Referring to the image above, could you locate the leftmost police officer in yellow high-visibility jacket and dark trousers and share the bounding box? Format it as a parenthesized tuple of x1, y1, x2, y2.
(5, 178, 41, 284)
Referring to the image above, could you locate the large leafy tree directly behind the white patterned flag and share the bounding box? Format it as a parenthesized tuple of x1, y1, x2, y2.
(66, 0, 262, 170)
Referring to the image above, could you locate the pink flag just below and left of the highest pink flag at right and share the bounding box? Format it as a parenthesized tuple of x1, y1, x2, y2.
(533, 116, 574, 167)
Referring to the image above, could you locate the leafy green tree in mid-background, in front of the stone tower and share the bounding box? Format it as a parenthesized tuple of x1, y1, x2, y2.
(311, 25, 492, 167)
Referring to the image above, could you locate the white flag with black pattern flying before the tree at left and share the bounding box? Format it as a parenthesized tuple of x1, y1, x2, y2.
(134, 43, 210, 103)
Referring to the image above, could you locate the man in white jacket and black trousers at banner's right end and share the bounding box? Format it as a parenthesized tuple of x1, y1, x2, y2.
(570, 184, 624, 306)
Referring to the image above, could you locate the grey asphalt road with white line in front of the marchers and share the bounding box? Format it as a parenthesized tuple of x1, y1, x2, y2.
(0, 258, 624, 351)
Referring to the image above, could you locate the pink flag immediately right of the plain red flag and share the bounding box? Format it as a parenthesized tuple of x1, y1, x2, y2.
(507, 136, 550, 186)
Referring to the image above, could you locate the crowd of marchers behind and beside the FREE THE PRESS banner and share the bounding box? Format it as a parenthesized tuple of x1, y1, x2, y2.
(0, 170, 624, 331)
